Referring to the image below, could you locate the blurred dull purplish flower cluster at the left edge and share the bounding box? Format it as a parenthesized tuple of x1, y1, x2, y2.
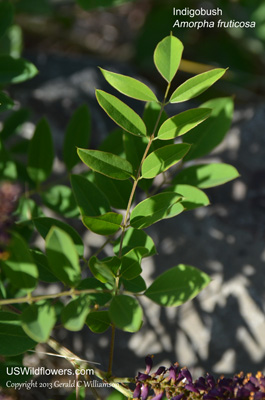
(0, 182, 20, 258)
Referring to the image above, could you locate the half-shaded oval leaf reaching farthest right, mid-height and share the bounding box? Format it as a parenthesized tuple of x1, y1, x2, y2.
(172, 163, 239, 189)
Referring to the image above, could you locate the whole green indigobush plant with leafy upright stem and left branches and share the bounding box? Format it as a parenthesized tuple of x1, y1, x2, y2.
(0, 35, 238, 399)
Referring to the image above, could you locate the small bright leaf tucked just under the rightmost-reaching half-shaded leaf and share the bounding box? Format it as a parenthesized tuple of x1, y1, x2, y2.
(166, 184, 210, 210)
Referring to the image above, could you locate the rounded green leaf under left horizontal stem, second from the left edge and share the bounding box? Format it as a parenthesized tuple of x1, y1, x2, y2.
(61, 294, 90, 332)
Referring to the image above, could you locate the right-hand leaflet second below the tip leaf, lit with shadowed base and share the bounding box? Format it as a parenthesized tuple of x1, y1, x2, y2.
(157, 108, 212, 140)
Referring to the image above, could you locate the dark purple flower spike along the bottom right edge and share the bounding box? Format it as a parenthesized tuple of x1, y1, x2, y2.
(134, 356, 265, 400)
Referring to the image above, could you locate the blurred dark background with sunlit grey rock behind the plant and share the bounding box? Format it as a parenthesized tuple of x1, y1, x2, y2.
(0, 0, 265, 399)
